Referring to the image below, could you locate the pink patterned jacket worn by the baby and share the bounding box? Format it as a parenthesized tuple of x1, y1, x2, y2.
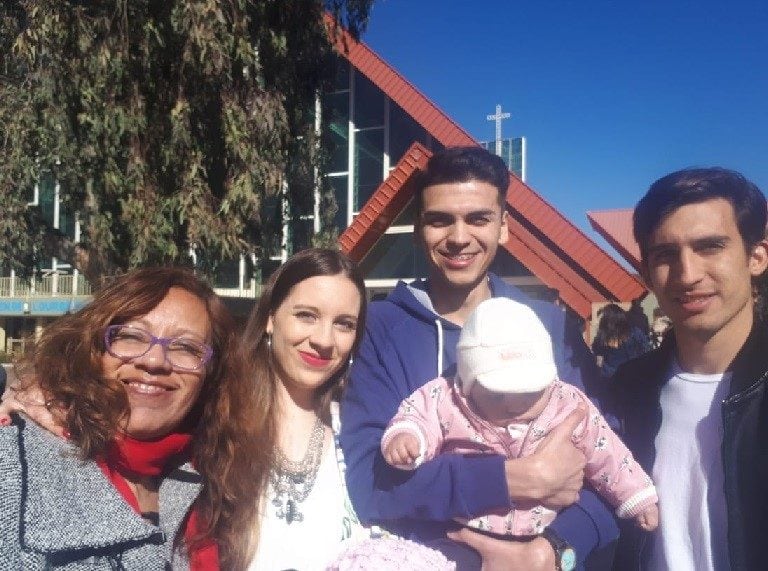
(381, 377, 658, 536)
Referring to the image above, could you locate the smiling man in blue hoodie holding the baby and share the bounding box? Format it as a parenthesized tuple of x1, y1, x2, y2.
(341, 147, 617, 570)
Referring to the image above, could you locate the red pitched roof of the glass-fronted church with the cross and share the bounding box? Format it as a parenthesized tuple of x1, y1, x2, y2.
(329, 17, 645, 317)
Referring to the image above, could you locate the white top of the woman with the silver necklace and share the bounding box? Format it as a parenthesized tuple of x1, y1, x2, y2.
(248, 439, 350, 571)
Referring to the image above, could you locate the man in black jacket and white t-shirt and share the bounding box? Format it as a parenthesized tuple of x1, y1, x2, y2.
(612, 168, 768, 571)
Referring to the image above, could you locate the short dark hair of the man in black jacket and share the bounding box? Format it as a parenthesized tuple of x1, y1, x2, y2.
(633, 167, 766, 263)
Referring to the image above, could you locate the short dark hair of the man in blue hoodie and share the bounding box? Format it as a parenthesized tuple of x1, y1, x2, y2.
(414, 147, 509, 212)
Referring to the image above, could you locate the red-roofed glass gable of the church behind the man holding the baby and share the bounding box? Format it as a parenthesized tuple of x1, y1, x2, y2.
(328, 16, 645, 319)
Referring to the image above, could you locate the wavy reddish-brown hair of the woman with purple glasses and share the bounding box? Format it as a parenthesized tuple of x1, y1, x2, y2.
(19, 268, 263, 569)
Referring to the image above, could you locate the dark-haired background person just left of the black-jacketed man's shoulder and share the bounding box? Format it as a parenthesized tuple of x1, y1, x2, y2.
(592, 303, 651, 381)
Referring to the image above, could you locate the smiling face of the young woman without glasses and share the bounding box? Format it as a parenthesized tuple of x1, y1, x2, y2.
(267, 274, 362, 398)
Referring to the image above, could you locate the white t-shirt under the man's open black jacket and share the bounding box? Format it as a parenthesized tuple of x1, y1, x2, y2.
(648, 364, 731, 571)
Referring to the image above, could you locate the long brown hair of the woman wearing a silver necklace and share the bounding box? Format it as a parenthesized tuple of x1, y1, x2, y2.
(242, 248, 366, 553)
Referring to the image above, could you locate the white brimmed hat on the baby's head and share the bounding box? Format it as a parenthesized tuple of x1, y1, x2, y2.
(456, 297, 557, 396)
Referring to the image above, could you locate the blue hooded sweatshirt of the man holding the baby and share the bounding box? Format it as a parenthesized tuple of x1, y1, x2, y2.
(341, 274, 618, 563)
